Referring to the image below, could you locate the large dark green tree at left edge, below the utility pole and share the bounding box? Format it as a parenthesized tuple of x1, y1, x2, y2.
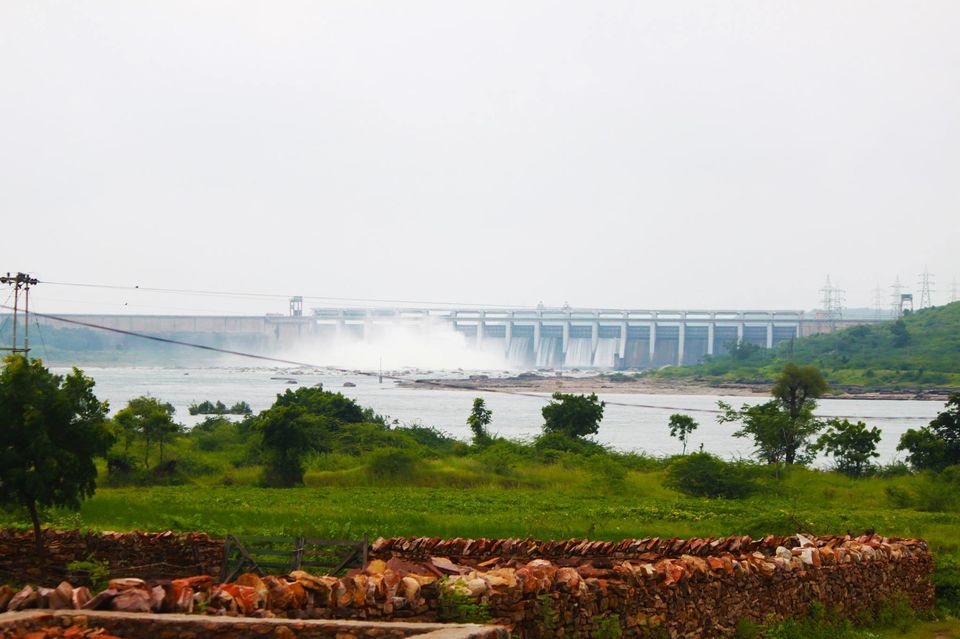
(0, 355, 113, 553)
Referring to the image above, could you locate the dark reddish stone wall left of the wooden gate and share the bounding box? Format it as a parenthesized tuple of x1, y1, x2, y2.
(0, 529, 223, 585)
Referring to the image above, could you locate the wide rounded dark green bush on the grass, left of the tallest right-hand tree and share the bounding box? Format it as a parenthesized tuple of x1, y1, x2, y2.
(664, 453, 757, 499)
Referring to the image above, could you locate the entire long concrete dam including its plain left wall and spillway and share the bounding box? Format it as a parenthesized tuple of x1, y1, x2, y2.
(26, 298, 871, 370)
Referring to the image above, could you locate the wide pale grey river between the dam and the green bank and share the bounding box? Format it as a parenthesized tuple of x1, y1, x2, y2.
(55, 367, 943, 463)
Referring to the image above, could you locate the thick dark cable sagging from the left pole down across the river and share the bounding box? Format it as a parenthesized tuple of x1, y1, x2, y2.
(0, 305, 929, 420)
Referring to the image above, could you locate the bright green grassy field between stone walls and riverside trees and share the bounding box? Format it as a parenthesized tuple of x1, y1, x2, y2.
(0, 459, 960, 554)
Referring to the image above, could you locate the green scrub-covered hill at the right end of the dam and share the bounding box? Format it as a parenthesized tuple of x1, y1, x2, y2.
(656, 302, 960, 388)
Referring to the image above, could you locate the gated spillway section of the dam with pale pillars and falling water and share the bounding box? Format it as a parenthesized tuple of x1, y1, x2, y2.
(313, 307, 863, 369)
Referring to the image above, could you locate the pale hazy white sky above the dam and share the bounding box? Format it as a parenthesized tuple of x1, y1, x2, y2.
(0, 0, 960, 312)
